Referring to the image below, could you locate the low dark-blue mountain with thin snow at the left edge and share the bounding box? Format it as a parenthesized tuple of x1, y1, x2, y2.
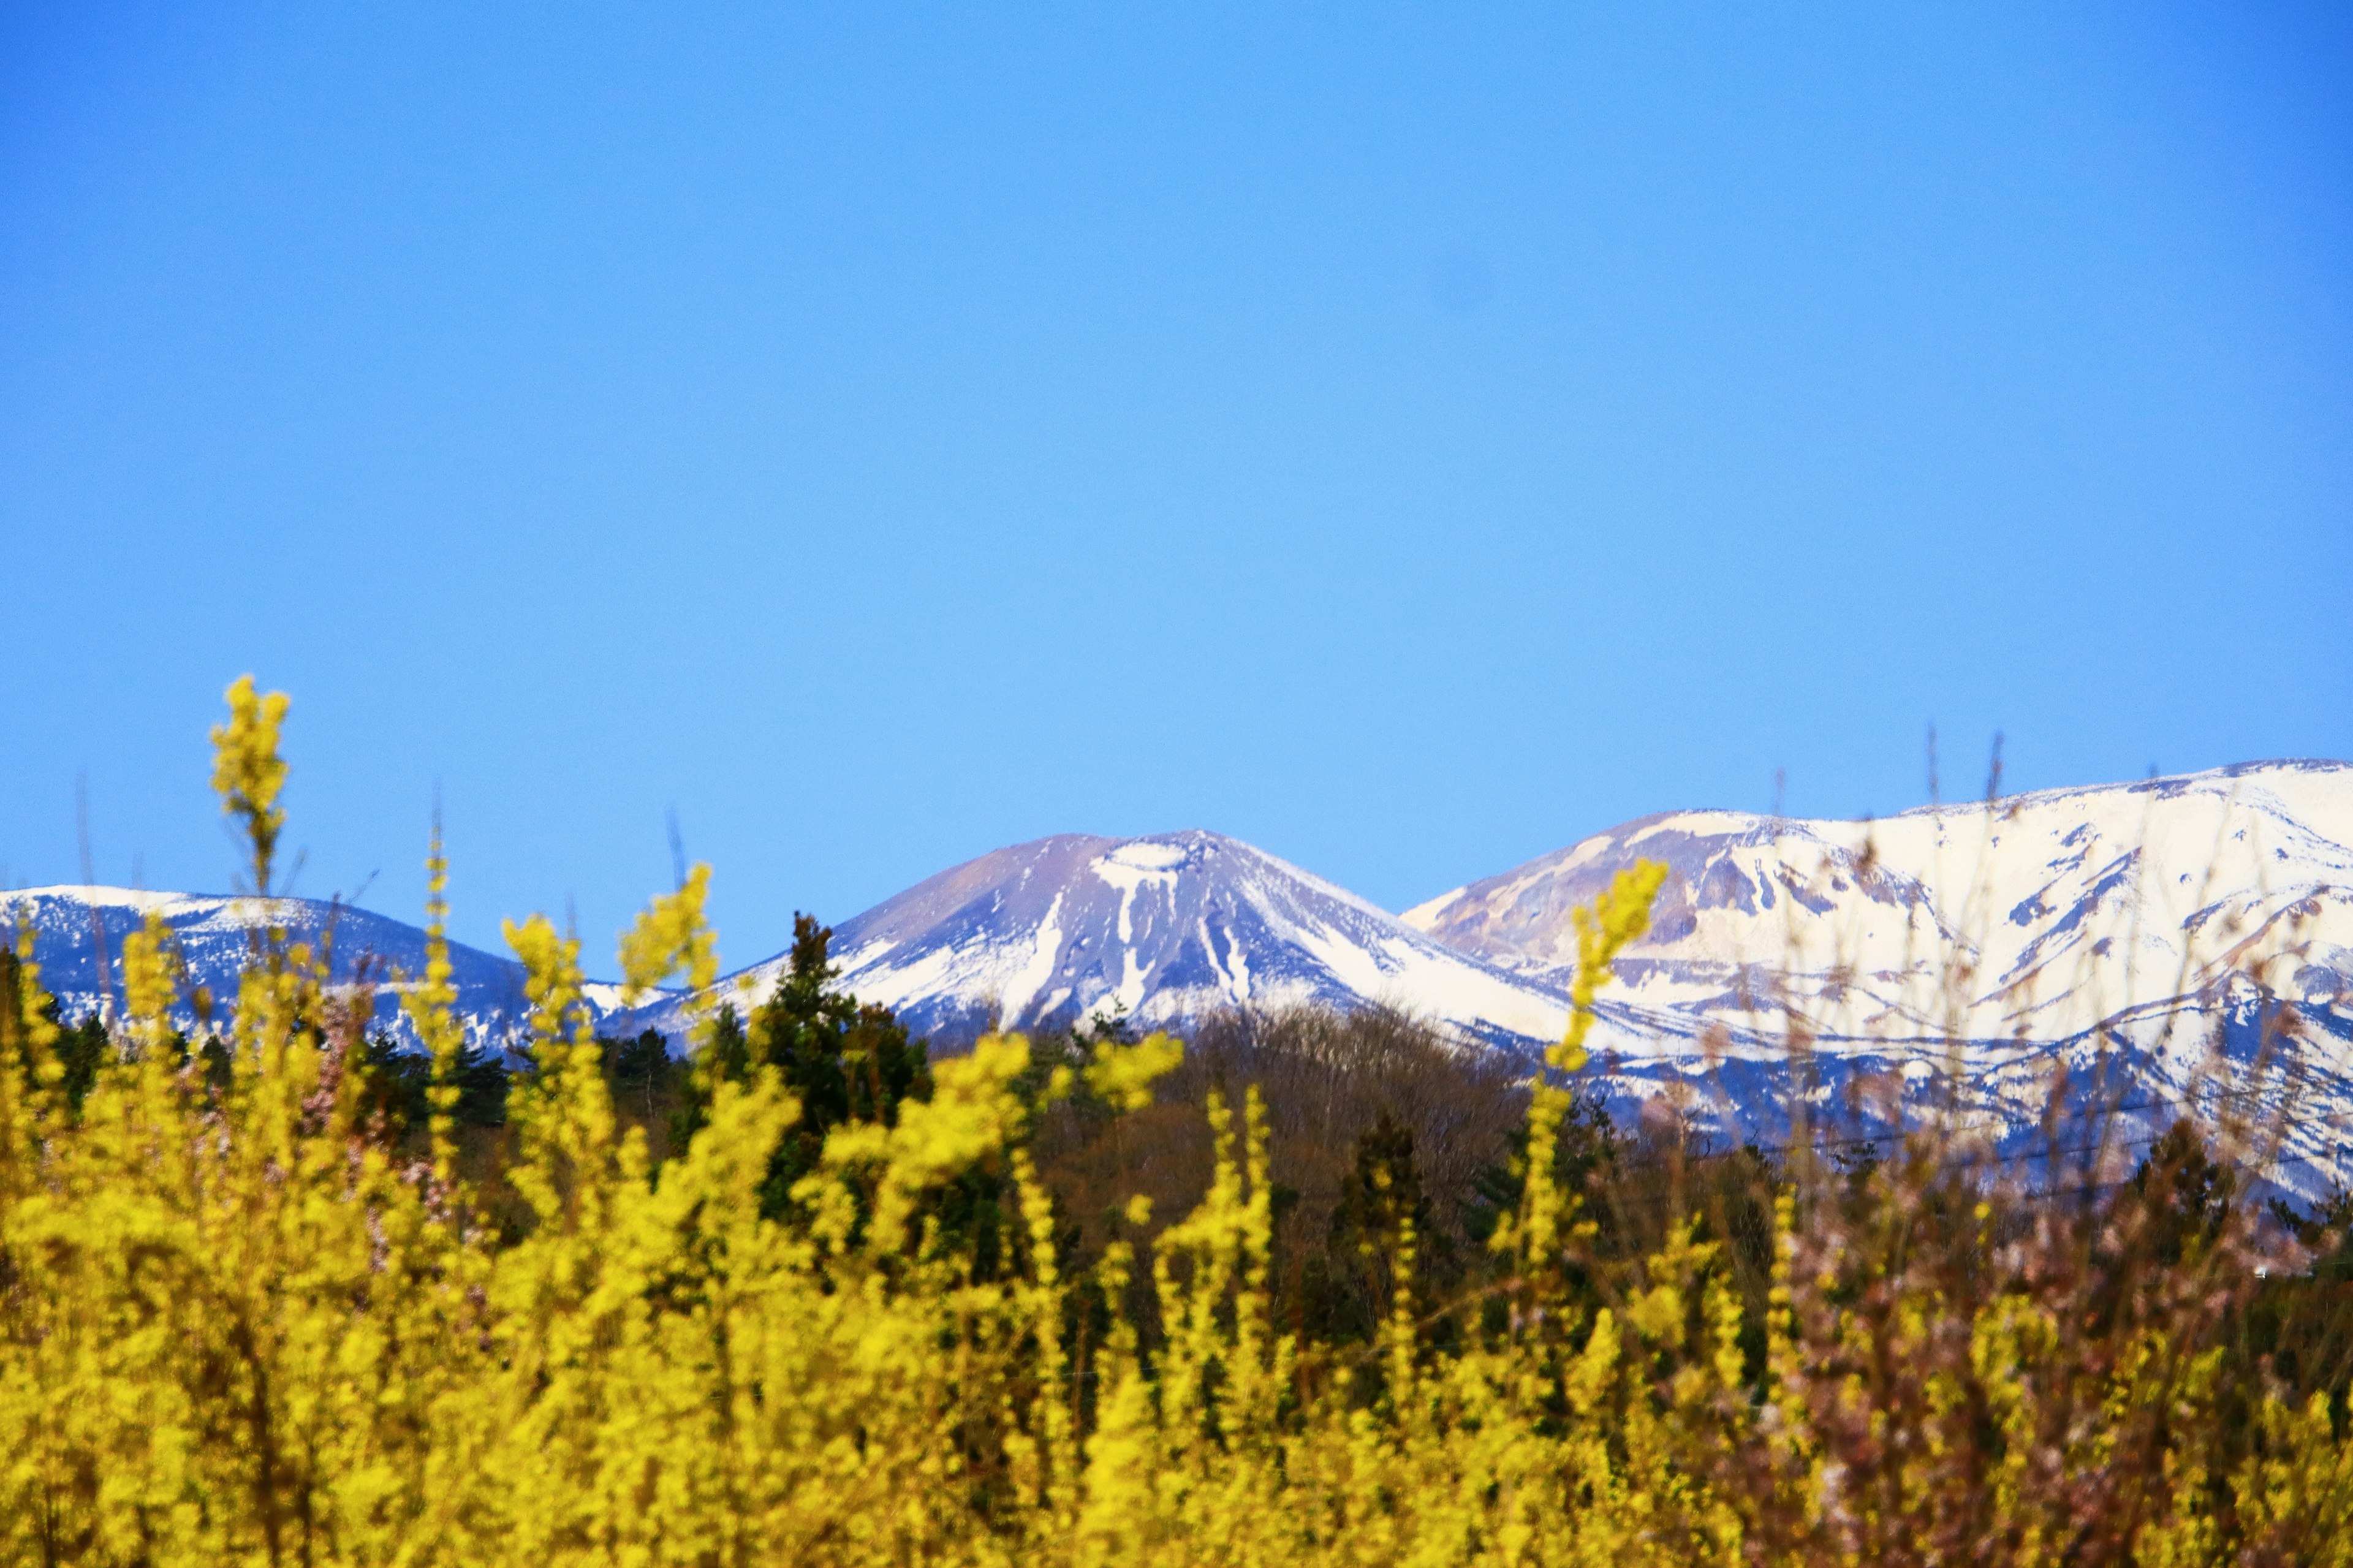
(0, 888, 654, 1045)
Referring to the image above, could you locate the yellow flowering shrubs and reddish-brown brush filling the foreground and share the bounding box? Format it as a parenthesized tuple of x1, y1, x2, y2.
(0, 680, 2353, 1568)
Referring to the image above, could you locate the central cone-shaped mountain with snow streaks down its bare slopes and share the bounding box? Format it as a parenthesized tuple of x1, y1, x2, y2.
(612, 831, 1565, 1045)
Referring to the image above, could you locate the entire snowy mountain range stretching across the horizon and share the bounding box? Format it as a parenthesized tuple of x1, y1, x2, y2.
(14, 763, 2353, 1187)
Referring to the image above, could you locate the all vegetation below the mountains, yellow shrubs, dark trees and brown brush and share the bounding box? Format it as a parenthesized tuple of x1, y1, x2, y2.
(0, 680, 2353, 1568)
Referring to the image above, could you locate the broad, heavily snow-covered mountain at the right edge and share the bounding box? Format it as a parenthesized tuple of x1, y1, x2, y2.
(1404, 763, 2353, 1172)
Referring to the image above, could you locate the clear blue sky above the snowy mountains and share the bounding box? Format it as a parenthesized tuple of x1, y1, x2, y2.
(0, 2, 2353, 968)
